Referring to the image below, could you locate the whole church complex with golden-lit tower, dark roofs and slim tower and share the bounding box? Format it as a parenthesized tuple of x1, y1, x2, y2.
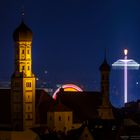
(0, 21, 114, 139)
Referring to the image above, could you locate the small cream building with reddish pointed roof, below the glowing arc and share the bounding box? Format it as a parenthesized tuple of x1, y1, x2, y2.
(47, 98, 81, 132)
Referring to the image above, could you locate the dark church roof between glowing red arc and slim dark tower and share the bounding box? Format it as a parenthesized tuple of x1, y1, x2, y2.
(58, 91, 101, 122)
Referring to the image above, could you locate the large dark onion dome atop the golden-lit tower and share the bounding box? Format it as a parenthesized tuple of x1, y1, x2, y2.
(13, 21, 32, 42)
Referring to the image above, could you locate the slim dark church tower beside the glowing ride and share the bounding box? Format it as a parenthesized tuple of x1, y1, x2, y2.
(98, 57, 114, 119)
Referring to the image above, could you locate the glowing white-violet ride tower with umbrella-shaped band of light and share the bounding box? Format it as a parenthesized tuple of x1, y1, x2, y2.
(112, 49, 140, 103)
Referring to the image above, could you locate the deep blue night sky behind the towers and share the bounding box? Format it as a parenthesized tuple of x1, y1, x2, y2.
(0, 0, 140, 106)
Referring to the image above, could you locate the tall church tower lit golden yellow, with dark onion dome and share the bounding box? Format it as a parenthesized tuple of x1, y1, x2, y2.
(11, 21, 36, 131)
